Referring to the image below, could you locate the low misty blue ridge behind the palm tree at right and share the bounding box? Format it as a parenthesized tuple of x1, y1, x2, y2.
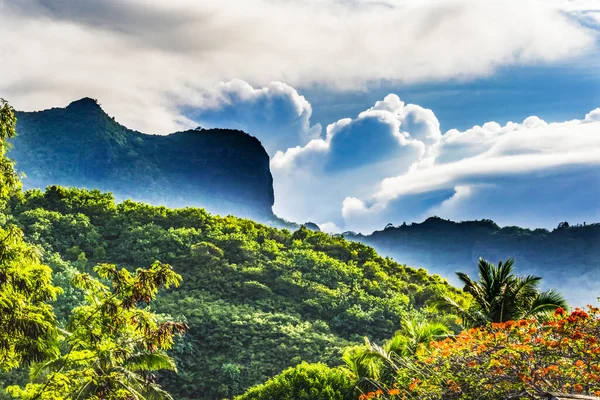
(344, 217, 600, 306)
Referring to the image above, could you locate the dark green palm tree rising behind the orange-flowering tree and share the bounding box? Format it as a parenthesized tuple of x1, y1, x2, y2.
(442, 258, 567, 326)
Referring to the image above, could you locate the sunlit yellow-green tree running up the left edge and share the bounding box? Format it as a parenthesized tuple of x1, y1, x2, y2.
(0, 99, 60, 399)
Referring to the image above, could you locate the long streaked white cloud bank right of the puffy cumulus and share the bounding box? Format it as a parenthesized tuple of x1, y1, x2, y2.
(342, 111, 600, 230)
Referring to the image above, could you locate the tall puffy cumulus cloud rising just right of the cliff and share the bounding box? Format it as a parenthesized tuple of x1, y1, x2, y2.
(271, 94, 441, 223)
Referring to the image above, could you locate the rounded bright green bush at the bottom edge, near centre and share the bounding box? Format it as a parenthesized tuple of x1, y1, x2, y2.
(236, 363, 356, 400)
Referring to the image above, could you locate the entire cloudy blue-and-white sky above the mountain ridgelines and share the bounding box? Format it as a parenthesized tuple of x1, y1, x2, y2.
(0, 0, 600, 233)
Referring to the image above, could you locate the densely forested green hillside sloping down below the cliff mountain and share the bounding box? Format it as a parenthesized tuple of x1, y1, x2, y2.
(3, 187, 468, 400)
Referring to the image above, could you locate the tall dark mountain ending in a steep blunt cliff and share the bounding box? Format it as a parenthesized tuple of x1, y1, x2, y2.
(9, 98, 274, 221)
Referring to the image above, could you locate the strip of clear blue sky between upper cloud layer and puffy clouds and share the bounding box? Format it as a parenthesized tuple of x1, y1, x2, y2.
(300, 56, 600, 130)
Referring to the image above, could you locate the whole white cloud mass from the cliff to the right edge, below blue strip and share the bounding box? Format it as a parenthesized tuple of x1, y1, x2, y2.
(256, 88, 600, 232)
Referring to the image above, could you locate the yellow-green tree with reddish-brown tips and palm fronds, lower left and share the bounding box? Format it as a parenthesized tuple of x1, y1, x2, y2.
(8, 262, 185, 400)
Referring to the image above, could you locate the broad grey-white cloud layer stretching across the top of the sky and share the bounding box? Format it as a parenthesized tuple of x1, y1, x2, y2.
(0, 0, 596, 134)
